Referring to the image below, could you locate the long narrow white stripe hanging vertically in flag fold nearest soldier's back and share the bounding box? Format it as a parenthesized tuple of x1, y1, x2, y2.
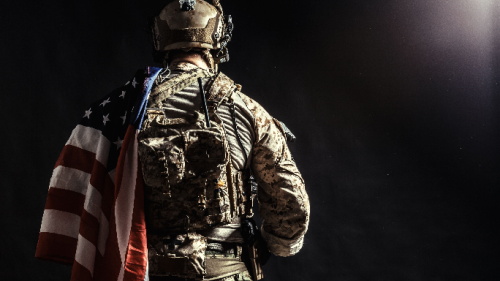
(115, 131, 138, 270)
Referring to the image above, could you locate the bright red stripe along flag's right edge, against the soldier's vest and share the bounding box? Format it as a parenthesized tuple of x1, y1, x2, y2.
(124, 160, 147, 281)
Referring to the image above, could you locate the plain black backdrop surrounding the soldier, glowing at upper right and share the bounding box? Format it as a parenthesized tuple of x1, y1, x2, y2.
(0, 0, 500, 281)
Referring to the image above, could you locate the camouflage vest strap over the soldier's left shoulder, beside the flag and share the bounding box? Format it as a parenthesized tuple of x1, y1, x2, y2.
(148, 68, 213, 108)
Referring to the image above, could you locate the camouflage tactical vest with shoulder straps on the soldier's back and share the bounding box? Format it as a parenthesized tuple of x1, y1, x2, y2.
(138, 69, 255, 233)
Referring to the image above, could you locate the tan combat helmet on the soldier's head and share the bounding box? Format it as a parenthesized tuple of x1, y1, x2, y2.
(149, 0, 233, 64)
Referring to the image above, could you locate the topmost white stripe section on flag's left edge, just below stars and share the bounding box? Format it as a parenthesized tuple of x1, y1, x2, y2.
(66, 125, 111, 166)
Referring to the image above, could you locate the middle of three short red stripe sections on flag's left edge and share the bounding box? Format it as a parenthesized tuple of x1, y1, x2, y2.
(45, 188, 85, 216)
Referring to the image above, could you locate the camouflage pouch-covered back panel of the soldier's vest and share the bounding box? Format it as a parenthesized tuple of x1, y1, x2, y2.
(139, 107, 232, 231)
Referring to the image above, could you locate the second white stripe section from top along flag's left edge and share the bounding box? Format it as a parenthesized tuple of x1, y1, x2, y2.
(49, 166, 90, 195)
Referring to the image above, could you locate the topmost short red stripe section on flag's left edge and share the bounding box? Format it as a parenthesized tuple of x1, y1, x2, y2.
(54, 145, 95, 174)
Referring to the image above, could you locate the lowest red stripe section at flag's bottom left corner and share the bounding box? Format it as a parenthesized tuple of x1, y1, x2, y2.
(35, 232, 77, 265)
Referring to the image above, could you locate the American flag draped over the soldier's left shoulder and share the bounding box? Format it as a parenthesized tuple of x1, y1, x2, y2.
(35, 67, 161, 281)
